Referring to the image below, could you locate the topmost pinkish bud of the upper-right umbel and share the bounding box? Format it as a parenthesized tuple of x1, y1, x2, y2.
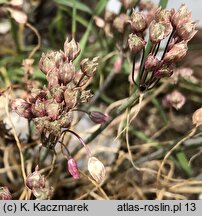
(171, 4, 191, 27)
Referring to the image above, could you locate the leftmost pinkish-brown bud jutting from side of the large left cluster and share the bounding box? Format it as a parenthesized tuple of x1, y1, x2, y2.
(11, 99, 33, 119)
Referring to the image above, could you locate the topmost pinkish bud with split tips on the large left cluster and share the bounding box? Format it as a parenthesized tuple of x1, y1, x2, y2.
(64, 38, 81, 61)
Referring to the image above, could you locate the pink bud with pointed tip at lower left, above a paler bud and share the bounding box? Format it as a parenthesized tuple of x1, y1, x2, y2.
(26, 165, 45, 190)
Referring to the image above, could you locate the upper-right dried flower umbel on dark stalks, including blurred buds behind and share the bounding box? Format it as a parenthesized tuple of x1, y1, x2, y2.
(96, 3, 197, 92)
